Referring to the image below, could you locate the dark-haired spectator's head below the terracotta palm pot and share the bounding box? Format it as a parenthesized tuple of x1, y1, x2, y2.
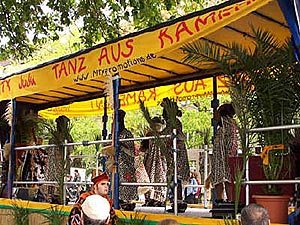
(241, 203, 270, 225)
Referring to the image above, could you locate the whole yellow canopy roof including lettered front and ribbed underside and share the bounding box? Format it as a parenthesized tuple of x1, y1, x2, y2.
(0, 0, 291, 110)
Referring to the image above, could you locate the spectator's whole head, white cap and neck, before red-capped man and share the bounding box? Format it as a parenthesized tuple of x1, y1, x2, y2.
(81, 195, 110, 225)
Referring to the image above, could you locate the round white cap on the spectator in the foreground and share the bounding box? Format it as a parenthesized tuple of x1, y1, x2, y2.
(81, 195, 110, 220)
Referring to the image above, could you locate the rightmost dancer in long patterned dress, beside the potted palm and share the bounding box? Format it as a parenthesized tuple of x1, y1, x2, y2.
(211, 104, 237, 203)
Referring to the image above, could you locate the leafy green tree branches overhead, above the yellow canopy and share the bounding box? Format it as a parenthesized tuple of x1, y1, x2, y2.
(0, 0, 220, 60)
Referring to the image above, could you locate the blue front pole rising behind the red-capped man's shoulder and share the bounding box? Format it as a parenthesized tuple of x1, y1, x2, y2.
(113, 75, 120, 209)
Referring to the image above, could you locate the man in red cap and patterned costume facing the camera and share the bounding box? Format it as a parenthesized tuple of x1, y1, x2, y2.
(68, 173, 116, 225)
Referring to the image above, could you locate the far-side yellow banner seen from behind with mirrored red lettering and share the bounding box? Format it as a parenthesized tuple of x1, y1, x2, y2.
(39, 77, 228, 119)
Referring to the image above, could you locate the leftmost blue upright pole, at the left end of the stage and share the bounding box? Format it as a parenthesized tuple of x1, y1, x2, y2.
(6, 99, 17, 198)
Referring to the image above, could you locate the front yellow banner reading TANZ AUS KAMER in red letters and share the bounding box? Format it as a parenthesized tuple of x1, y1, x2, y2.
(0, 0, 270, 101)
